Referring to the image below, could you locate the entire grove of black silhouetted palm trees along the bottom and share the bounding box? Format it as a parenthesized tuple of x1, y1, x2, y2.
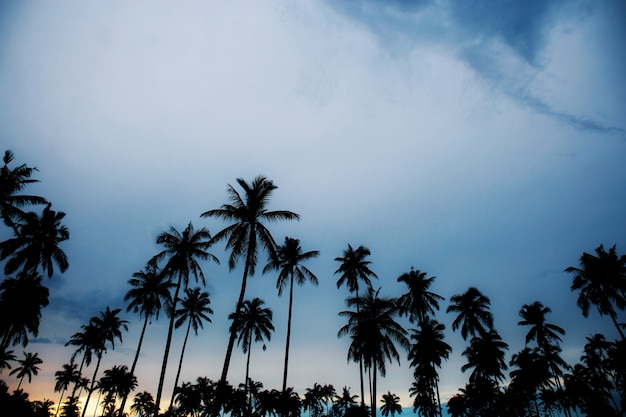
(0, 151, 626, 417)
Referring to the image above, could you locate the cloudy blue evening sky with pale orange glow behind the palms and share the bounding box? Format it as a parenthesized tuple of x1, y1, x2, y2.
(0, 0, 626, 412)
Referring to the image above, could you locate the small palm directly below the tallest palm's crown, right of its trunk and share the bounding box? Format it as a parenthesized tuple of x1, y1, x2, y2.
(229, 297, 274, 412)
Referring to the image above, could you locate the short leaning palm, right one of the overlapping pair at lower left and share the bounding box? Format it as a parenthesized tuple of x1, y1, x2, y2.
(83, 307, 128, 417)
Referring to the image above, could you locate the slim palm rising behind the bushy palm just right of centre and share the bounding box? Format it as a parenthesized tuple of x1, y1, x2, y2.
(335, 244, 378, 406)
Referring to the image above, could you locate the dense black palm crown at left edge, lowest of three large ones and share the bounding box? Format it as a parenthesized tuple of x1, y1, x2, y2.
(0, 271, 49, 349)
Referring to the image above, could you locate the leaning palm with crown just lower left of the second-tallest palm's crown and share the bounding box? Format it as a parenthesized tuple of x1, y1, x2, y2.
(120, 262, 174, 413)
